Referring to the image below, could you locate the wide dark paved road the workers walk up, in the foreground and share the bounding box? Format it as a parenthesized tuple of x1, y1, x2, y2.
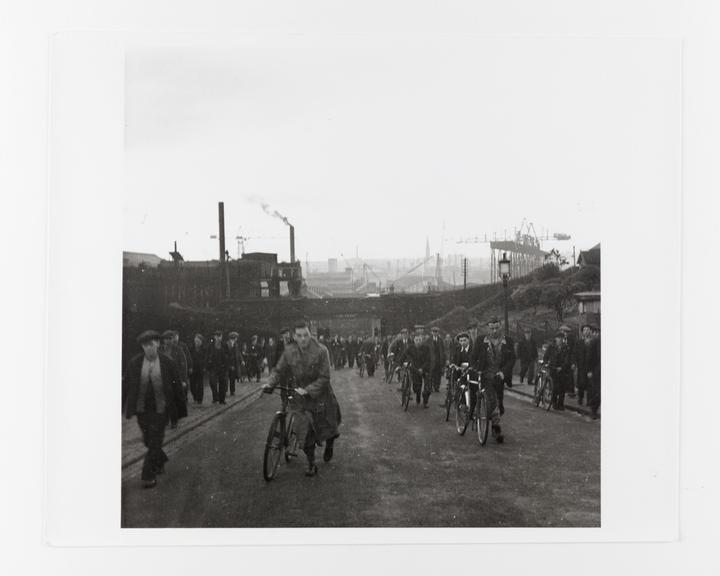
(122, 369, 600, 527)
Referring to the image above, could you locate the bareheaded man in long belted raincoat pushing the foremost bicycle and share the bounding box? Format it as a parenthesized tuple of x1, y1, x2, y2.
(262, 323, 341, 476)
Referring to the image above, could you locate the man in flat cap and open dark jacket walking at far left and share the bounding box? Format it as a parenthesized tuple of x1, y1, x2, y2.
(125, 330, 187, 488)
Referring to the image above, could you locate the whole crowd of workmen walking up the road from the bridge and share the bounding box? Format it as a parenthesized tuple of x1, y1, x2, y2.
(123, 317, 600, 487)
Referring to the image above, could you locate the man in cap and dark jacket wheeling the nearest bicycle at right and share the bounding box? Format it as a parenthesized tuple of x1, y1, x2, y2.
(473, 316, 515, 444)
